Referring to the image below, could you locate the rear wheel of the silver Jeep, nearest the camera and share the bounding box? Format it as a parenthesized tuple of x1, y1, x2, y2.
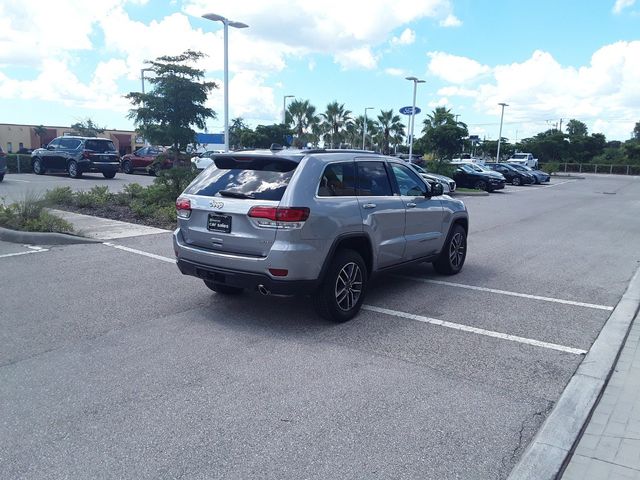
(313, 250, 367, 323)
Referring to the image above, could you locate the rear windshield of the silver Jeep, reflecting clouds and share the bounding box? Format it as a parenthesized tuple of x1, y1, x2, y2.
(185, 156, 298, 201)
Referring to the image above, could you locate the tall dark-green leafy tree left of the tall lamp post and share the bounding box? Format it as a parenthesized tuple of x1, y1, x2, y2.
(126, 50, 218, 164)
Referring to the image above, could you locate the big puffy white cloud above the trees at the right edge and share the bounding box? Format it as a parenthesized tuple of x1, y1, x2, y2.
(476, 41, 640, 139)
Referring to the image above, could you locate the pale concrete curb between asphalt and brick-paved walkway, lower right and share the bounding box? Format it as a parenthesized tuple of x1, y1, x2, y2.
(508, 268, 640, 480)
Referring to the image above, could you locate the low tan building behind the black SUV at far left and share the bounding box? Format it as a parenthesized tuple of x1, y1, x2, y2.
(0, 123, 144, 155)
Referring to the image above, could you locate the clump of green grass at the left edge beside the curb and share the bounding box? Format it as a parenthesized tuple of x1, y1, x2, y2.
(0, 194, 73, 233)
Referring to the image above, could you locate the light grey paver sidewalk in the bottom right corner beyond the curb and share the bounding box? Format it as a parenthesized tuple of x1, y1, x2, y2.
(562, 314, 640, 480)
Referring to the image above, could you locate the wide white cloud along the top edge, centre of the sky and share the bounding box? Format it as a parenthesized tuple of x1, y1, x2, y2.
(185, 0, 460, 68)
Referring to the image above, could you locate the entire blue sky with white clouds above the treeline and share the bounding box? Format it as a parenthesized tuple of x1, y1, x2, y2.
(0, 0, 640, 141)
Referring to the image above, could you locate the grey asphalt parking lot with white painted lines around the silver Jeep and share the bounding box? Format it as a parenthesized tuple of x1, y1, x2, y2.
(0, 174, 640, 479)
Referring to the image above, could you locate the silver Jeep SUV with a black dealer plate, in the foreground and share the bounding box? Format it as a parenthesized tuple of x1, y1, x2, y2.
(173, 150, 469, 321)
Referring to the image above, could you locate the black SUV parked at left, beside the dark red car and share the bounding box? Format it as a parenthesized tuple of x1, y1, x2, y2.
(31, 136, 120, 178)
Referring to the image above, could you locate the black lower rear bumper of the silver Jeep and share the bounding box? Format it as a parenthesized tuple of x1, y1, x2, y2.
(176, 259, 318, 295)
